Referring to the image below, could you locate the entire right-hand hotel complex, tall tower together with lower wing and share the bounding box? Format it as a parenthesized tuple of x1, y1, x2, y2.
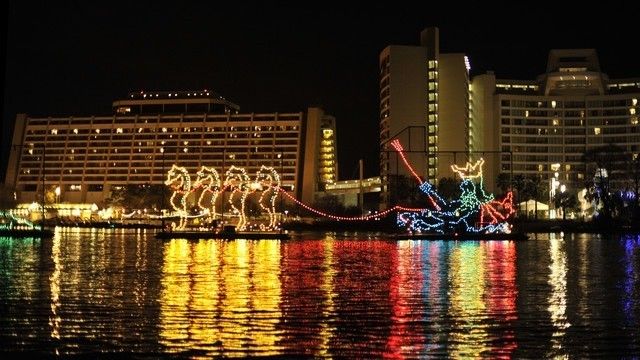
(379, 28, 640, 207)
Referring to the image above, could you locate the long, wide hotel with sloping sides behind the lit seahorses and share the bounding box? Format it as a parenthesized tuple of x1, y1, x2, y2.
(5, 90, 338, 212)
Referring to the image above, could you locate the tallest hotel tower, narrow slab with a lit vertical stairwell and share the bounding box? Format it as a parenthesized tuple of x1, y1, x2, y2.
(379, 28, 470, 207)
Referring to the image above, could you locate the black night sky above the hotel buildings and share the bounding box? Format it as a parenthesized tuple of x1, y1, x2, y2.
(0, 1, 640, 181)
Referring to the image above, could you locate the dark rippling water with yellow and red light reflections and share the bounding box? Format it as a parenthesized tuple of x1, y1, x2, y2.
(0, 229, 640, 358)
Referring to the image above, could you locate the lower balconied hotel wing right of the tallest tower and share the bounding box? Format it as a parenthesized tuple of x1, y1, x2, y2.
(471, 49, 640, 194)
